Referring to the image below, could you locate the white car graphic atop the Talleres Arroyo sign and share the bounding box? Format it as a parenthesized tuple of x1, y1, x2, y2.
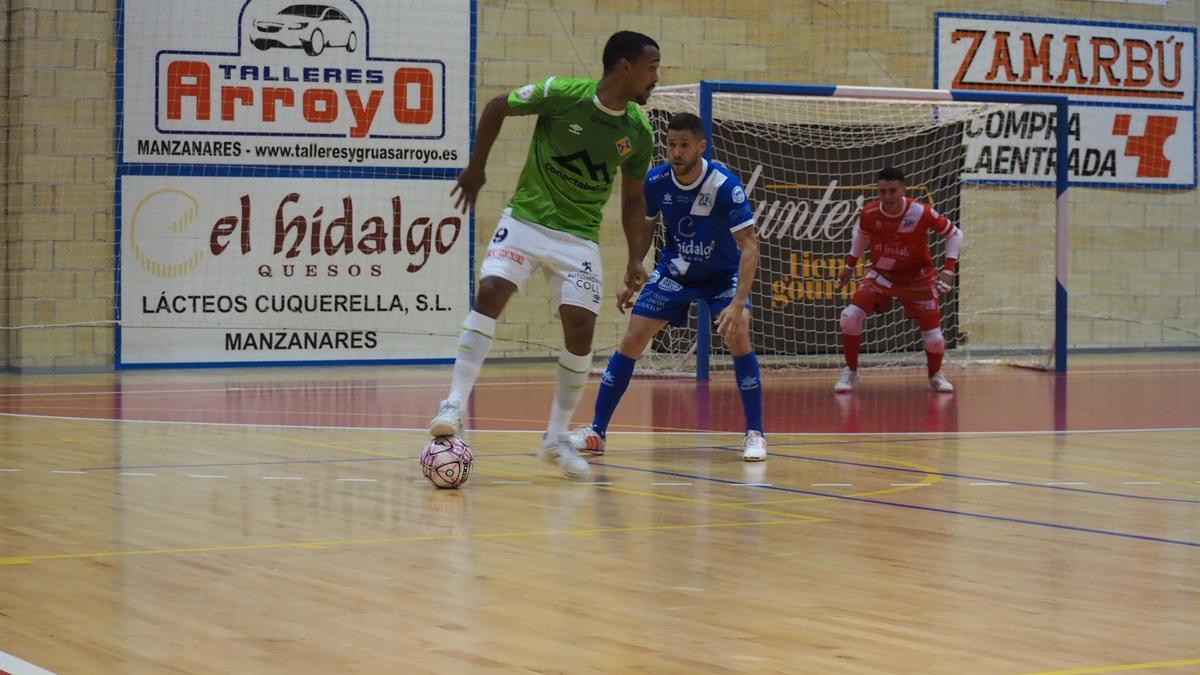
(250, 5, 359, 56)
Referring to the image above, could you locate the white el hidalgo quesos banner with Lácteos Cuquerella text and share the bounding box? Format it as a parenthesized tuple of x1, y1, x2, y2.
(120, 175, 470, 364)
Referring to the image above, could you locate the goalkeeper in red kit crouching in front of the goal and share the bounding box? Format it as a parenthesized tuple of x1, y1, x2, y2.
(834, 167, 962, 393)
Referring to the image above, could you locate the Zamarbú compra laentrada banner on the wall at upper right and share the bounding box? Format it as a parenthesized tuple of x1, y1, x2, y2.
(935, 13, 1196, 189)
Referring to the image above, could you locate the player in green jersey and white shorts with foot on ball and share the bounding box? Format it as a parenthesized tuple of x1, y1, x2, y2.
(430, 31, 659, 479)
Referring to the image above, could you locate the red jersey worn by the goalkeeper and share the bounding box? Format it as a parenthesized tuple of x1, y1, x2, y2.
(858, 197, 954, 283)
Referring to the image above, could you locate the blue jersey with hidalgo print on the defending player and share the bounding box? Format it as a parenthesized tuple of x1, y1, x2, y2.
(646, 160, 754, 286)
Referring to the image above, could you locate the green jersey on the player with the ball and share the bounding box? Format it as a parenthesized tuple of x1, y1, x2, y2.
(509, 77, 654, 243)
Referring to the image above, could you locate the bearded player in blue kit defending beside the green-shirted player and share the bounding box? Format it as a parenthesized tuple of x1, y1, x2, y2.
(570, 113, 767, 461)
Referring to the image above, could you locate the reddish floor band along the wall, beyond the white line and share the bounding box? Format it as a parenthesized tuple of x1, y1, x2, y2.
(0, 365, 1200, 434)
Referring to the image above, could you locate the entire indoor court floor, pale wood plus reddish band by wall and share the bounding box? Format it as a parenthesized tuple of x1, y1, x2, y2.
(0, 354, 1200, 675)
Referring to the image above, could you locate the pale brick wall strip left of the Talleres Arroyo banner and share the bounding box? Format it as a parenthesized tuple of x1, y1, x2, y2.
(2, 0, 116, 370)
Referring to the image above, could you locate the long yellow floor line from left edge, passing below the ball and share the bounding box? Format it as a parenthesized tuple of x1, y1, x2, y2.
(0, 518, 809, 566)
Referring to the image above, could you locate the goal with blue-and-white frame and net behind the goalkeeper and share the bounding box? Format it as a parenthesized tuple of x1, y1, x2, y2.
(648, 80, 1069, 380)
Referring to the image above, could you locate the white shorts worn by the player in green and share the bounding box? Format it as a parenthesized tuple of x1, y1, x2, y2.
(479, 209, 604, 315)
